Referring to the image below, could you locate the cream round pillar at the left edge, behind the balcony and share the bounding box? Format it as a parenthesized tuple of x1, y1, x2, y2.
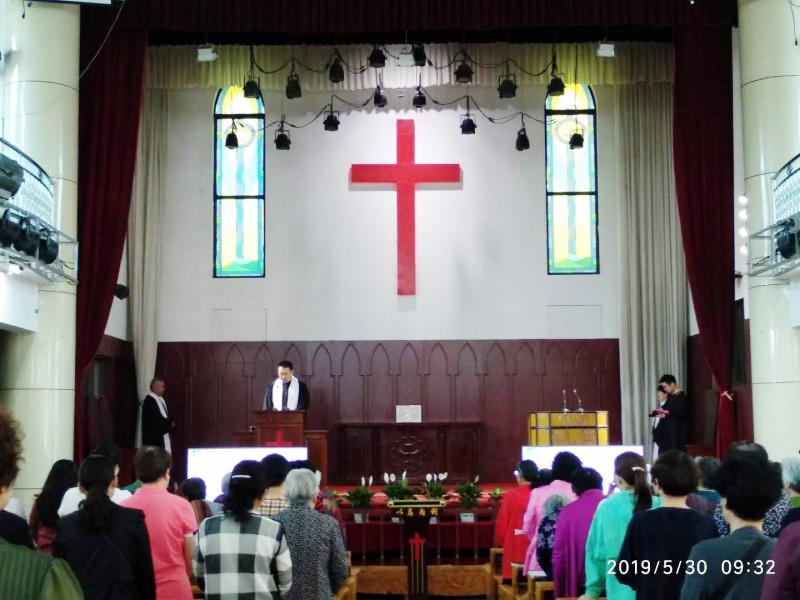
(0, 0, 80, 507)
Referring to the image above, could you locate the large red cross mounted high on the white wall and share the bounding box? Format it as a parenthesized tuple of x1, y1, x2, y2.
(350, 119, 461, 296)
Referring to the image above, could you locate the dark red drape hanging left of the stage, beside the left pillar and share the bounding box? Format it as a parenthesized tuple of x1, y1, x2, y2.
(75, 33, 147, 459)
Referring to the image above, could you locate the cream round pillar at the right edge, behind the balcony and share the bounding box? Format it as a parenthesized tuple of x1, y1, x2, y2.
(740, 0, 800, 460)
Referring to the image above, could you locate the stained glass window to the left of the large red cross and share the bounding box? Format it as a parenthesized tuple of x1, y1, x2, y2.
(214, 86, 264, 277)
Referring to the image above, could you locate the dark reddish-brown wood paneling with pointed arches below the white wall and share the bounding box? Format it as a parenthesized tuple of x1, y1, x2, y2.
(157, 339, 621, 483)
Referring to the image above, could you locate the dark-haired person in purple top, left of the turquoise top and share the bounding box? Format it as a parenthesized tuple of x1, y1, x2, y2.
(552, 468, 604, 598)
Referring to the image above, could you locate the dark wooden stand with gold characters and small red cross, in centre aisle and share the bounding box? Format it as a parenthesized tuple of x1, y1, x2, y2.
(389, 499, 447, 600)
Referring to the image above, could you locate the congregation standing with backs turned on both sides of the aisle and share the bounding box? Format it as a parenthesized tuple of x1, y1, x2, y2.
(0, 411, 800, 600)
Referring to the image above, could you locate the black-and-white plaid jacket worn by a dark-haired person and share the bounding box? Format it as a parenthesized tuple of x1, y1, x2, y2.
(193, 512, 292, 600)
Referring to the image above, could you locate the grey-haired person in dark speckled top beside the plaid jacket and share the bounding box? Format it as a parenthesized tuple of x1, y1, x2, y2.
(275, 469, 348, 600)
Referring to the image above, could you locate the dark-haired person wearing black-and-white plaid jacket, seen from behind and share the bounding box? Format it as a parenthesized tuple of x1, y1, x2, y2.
(193, 460, 292, 600)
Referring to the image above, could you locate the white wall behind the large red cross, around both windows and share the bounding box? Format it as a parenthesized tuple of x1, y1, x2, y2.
(159, 83, 619, 341)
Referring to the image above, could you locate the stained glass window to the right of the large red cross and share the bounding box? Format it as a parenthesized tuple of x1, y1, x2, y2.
(545, 84, 600, 275)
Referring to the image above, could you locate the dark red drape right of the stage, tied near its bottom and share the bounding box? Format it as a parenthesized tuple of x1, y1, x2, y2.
(672, 27, 734, 456)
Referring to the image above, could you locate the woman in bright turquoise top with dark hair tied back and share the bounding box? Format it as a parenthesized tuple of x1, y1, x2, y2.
(580, 452, 661, 600)
